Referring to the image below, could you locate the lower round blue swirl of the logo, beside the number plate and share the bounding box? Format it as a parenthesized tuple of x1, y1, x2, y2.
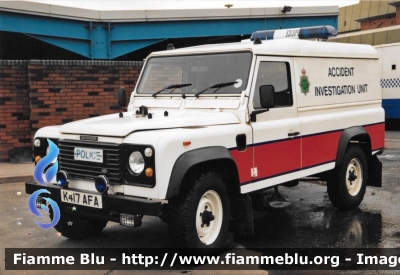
(28, 189, 60, 229)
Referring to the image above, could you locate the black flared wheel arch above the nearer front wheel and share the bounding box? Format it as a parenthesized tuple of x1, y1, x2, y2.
(166, 146, 240, 199)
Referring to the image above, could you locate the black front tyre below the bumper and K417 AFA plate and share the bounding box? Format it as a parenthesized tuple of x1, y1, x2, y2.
(50, 209, 107, 239)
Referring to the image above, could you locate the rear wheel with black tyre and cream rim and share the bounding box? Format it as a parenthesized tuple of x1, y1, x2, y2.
(328, 145, 368, 209)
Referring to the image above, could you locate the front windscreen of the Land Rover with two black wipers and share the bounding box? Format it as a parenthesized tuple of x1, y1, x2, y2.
(137, 52, 252, 95)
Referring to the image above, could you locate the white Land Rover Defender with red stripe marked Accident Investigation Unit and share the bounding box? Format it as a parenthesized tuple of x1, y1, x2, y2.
(26, 26, 384, 248)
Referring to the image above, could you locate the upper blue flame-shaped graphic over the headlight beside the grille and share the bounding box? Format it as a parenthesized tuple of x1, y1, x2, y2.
(33, 139, 60, 185)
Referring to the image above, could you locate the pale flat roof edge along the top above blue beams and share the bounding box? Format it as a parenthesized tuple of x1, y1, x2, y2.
(0, 1, 339, 22)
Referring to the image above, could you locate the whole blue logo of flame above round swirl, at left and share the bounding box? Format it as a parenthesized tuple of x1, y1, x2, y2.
(28, 139, 60, 229)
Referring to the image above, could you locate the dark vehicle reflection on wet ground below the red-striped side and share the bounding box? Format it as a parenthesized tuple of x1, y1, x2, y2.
(239, 194, 382, 248)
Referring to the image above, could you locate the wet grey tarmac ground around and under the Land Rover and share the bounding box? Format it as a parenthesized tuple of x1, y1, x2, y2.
(0, 132, 400, 274)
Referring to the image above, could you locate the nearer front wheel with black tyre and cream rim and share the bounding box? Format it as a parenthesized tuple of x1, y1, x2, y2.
(168, 172, 230, 248)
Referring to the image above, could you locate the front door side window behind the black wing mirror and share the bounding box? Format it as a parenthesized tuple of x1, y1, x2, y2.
(253, 61, 293, 109)
